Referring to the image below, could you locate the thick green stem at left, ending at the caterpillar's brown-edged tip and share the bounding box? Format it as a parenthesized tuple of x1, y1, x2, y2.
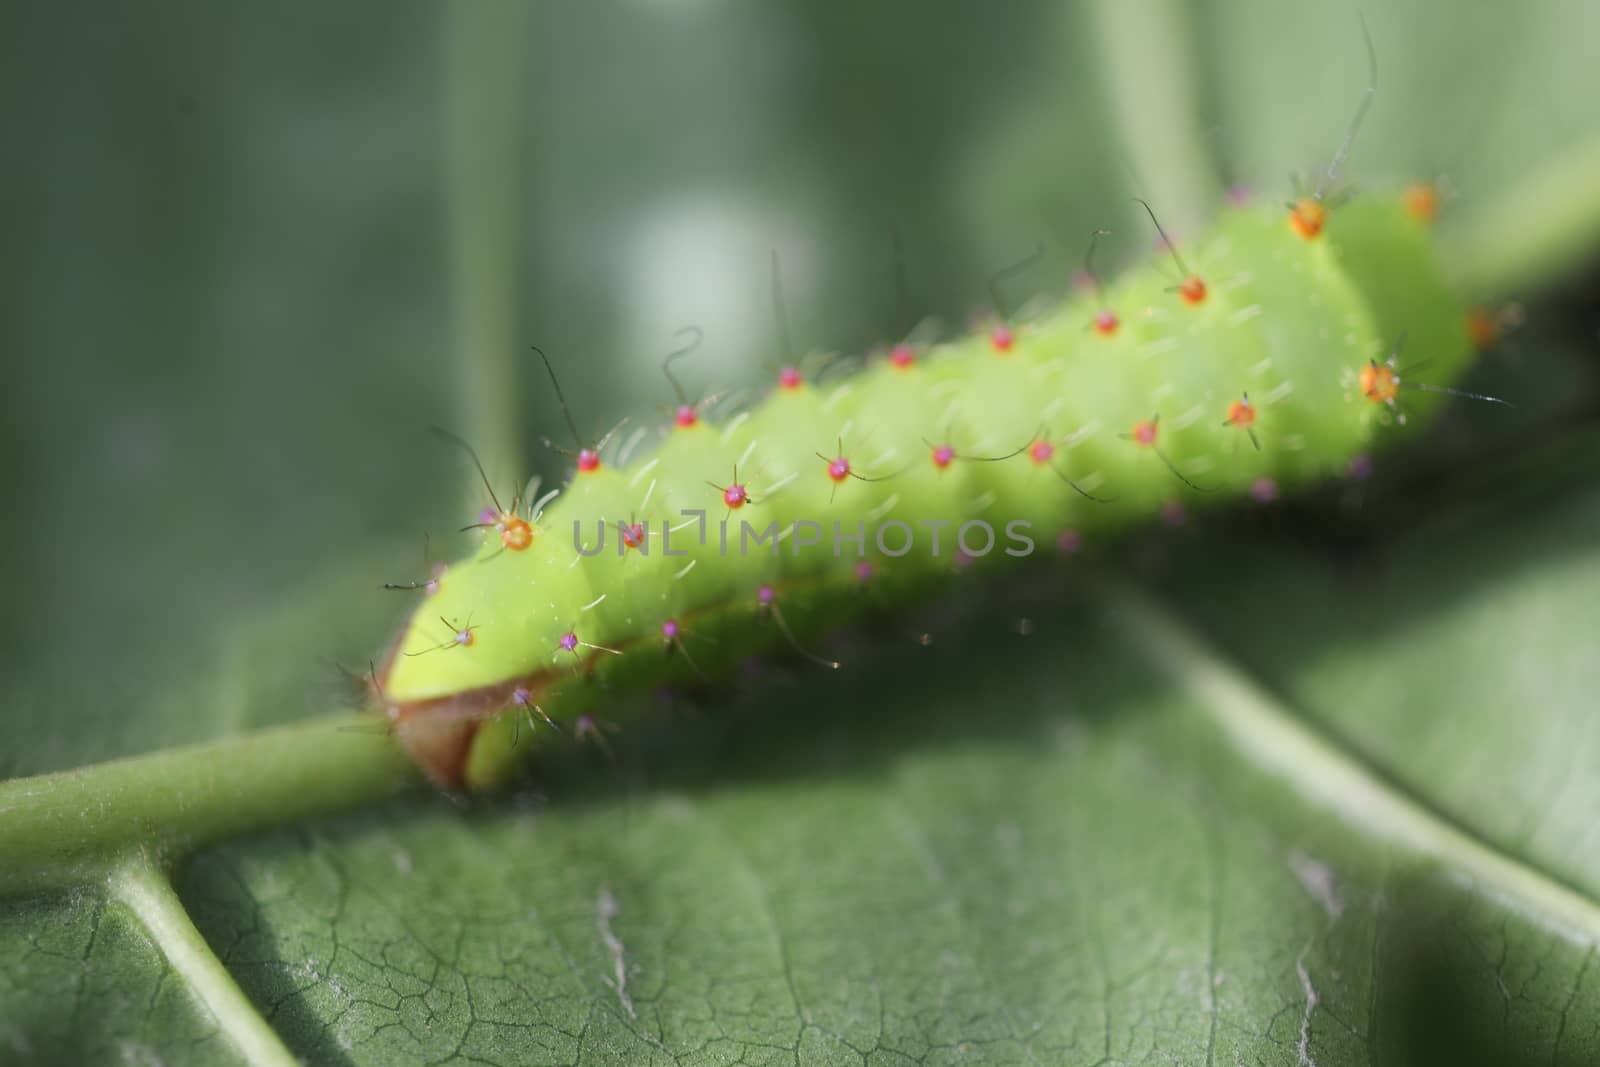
(0, 712, 421, 893)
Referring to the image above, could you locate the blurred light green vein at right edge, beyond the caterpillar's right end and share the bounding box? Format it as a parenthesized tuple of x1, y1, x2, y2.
(1440, 133, 1600, 299)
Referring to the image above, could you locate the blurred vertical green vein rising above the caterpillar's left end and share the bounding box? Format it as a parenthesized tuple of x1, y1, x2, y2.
(443, 0, 530, 515)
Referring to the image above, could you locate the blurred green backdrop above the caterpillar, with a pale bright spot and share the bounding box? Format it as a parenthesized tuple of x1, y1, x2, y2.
(0, 0, 1600, 774)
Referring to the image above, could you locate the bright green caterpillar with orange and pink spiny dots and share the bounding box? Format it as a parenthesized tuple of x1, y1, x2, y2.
(374, 195, 1472, 789)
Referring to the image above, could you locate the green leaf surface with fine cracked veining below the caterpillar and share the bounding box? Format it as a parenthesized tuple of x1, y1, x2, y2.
(13, 470, 1600, 1067)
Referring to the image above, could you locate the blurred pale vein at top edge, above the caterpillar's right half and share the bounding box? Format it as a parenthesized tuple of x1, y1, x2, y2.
(1093, 0, 1222, 232)
